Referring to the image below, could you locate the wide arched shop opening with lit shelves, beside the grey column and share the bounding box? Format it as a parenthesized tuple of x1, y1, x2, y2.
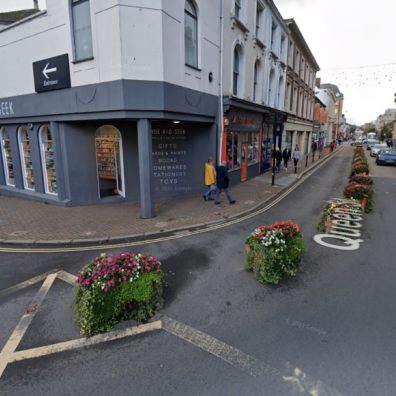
(95, 125, 125, 198)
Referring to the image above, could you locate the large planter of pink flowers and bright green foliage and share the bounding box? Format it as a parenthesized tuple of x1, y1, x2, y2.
(75, 252, 164, 336)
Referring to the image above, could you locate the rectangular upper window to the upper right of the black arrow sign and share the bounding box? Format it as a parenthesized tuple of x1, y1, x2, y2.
(71, 0, 93, 61)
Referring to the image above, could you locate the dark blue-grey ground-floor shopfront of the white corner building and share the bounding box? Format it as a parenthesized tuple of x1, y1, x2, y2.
(0, 64, 218, 217)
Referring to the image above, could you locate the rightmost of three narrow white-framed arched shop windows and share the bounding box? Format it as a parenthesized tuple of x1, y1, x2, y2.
(39, 125, 58, 195)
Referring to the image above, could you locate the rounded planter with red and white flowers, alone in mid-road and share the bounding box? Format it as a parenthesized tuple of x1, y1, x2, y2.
(246, 221, 305, 284)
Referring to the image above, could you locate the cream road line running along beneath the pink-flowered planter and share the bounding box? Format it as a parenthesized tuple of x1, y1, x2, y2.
(9, 320, 162, 363)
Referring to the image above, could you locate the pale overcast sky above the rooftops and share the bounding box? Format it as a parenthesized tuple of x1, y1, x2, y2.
(0, 0, 396, 124)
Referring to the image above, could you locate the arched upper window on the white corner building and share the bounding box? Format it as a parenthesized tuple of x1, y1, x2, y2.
(184, 0, 198, 67)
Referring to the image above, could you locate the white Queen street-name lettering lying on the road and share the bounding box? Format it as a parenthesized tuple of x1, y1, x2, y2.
(313, 200, 363, 250)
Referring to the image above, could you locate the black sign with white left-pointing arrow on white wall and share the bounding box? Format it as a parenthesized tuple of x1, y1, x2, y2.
(33, 54, 71, 92)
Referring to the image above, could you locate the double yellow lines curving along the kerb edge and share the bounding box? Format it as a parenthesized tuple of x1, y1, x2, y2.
(0, 150, 341, 253)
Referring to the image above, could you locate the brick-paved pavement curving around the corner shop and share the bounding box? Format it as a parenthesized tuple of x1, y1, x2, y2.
(0, 150, 337, 247)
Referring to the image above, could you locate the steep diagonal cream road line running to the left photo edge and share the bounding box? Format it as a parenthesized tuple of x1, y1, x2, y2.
(0, 274, 57, 378)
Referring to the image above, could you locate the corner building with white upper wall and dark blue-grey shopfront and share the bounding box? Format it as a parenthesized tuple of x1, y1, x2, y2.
(0, 0, 221, 217)
